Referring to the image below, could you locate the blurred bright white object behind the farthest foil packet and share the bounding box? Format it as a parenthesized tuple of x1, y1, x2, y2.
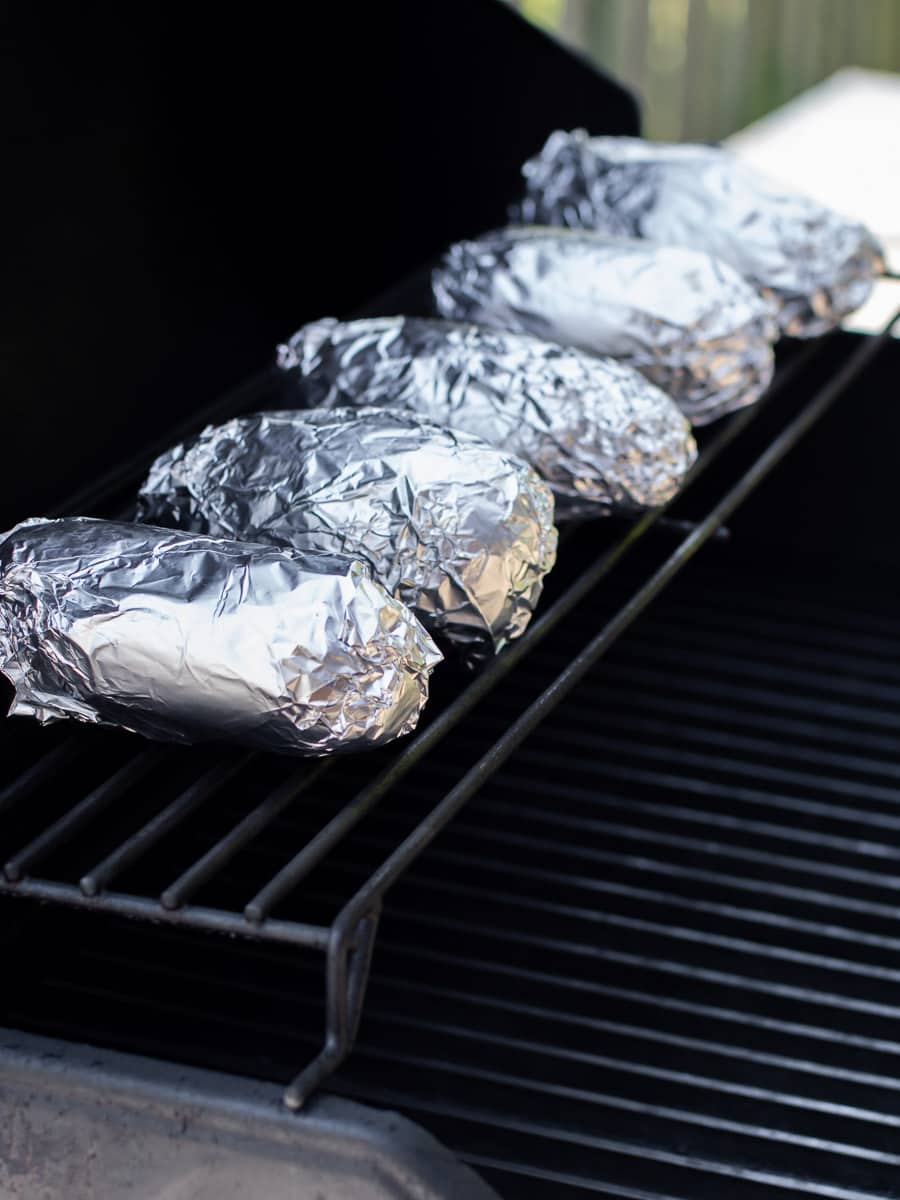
(726, 67, 900, 334)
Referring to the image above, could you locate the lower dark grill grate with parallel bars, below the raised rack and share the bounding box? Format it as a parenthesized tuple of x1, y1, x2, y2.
(332, 568, 900, 1200)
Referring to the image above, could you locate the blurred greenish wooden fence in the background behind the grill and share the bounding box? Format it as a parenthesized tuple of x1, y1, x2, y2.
(511, 0, 900, 142)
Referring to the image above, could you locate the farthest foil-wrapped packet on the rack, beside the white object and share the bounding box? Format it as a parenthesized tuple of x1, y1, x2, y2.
(512, 130, 884, 337)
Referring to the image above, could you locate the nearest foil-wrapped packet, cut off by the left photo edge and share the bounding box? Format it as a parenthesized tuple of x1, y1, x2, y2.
(0, 517, 440, 755)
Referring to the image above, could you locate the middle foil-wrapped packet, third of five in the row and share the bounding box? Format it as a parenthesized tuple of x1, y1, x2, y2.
(278, 317, 697, 518)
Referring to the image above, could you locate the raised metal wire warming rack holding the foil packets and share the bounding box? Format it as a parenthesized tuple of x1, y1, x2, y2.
(0, 312, 900, 1109)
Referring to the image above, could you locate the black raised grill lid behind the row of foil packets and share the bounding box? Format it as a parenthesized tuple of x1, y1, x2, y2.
(0, 0, 638, 528)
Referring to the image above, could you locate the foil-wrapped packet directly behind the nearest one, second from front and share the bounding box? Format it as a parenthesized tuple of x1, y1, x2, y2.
(138, 408, 557, 658)
